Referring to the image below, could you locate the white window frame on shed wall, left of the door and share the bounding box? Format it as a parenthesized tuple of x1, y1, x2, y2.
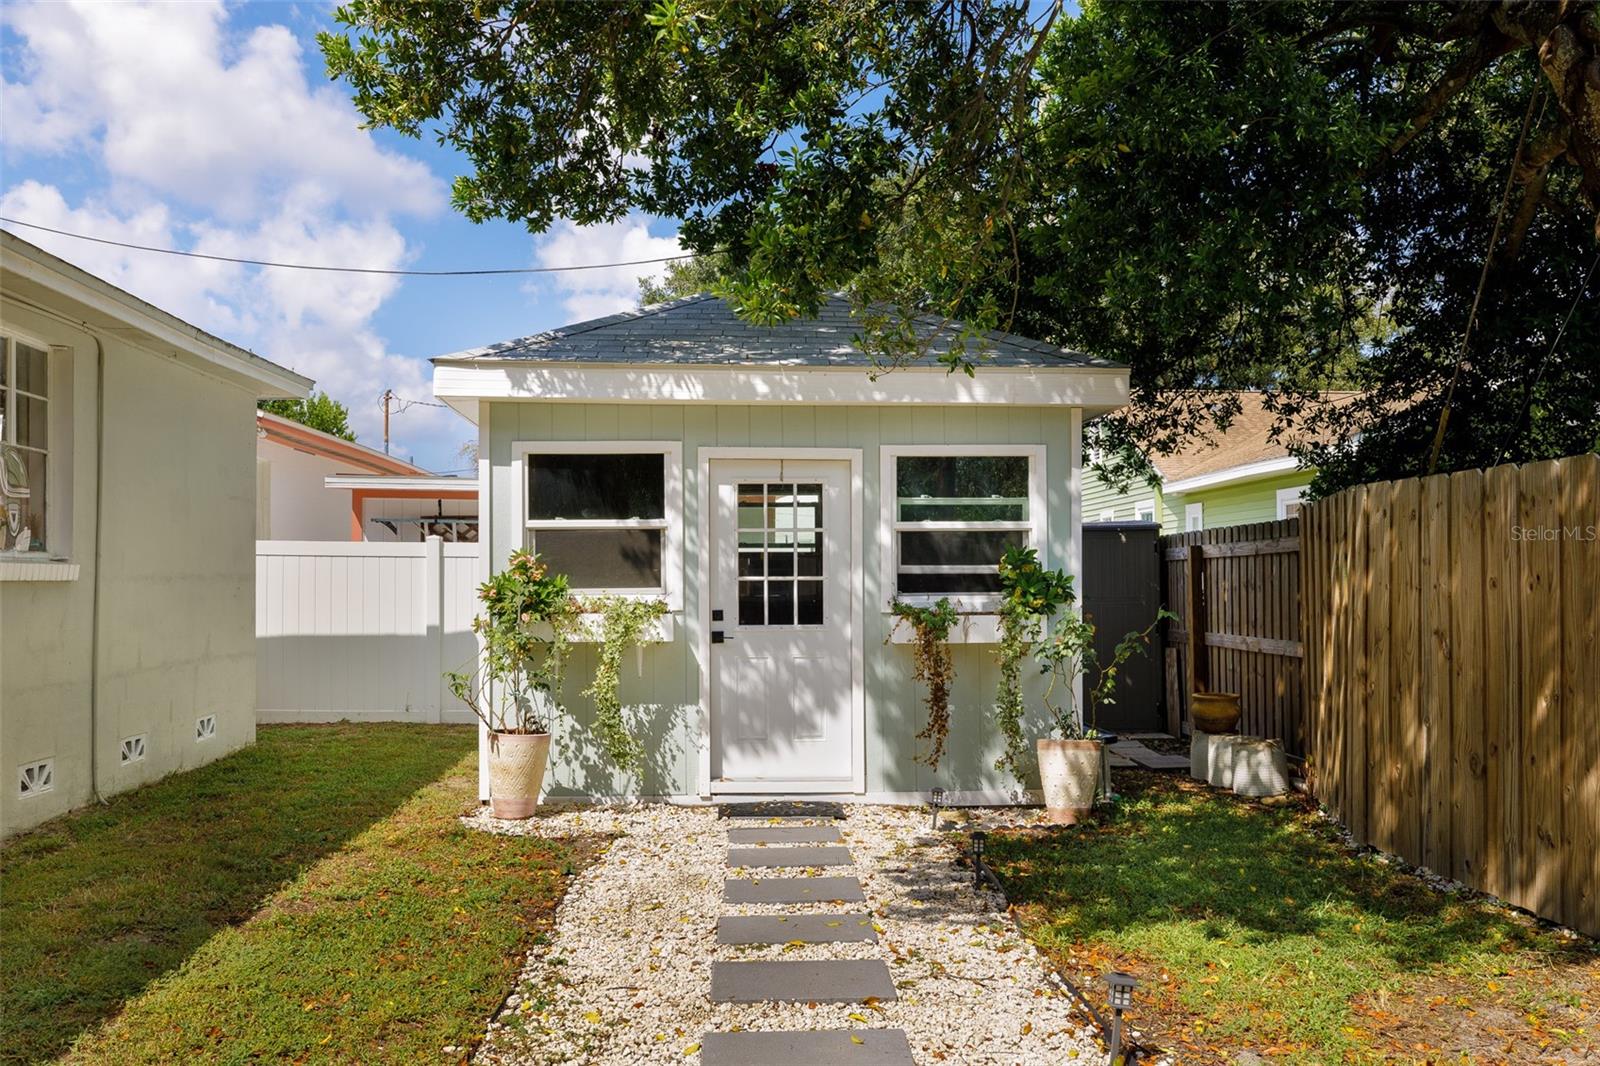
(512, 440, 683, 611)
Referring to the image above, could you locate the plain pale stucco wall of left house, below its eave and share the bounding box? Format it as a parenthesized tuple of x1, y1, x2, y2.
(0, 294, 256, 832)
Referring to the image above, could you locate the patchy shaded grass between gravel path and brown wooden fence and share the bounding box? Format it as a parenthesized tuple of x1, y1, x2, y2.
(989, 771, 1600, 1063)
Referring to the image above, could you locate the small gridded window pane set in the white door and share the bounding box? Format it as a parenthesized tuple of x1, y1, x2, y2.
(739, 482, 824, 626)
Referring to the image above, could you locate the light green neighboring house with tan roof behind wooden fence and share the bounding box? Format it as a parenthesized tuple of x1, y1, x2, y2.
(1083, 392, 1354, 533)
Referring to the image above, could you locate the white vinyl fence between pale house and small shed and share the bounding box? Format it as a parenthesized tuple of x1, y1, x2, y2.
(256, 536, 480, 722)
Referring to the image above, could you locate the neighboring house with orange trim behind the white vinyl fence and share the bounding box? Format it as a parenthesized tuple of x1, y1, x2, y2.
(256, 411, 478, 541)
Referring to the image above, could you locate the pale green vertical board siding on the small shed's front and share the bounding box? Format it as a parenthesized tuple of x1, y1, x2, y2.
(478, 400, 1077, 797)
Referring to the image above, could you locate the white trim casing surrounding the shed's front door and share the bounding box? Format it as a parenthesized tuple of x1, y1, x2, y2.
(686, 447, 867, 799)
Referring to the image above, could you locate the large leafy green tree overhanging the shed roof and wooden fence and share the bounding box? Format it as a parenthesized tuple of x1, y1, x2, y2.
(322, 0, 1600, 488)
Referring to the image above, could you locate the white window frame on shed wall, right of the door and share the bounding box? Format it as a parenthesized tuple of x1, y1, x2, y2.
(878, 445, 1050, 613)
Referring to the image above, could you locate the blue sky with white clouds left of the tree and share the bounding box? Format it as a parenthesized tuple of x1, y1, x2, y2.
(0, 3, 470, 461)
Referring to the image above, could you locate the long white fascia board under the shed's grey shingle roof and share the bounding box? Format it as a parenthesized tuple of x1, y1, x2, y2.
(434, 360, 1128, 418)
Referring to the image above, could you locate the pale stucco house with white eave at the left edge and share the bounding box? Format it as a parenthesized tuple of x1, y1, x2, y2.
(0, 232, 312, 834)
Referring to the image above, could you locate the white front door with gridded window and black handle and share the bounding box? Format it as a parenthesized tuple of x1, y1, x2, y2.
(709, 459, 856, 792)
